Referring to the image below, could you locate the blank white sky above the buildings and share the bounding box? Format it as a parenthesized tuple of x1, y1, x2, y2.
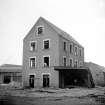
(0, 0, 105, 66)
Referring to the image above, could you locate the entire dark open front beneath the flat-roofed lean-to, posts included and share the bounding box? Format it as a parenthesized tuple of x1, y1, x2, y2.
(59, 69, 94, 88)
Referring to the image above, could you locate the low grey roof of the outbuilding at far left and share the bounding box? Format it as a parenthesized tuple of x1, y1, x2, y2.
(0, 64, 22, 72)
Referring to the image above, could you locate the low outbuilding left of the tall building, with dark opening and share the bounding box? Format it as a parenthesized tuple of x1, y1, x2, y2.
(0, 64, 22, 84)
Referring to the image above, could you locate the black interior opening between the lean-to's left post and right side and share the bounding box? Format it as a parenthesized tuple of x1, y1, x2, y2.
(64, 70, 88, 87)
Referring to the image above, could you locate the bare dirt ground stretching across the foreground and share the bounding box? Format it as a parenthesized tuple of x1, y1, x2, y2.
(0, 87, 105, 105)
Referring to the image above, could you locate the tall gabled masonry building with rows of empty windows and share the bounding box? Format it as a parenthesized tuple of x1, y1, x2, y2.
(22, 17, 93, 87)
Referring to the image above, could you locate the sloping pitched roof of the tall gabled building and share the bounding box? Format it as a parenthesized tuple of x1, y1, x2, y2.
(39, 17, 82, 47)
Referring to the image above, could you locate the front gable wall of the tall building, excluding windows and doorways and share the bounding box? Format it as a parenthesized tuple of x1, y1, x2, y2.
(23, 17, 59, 87)
